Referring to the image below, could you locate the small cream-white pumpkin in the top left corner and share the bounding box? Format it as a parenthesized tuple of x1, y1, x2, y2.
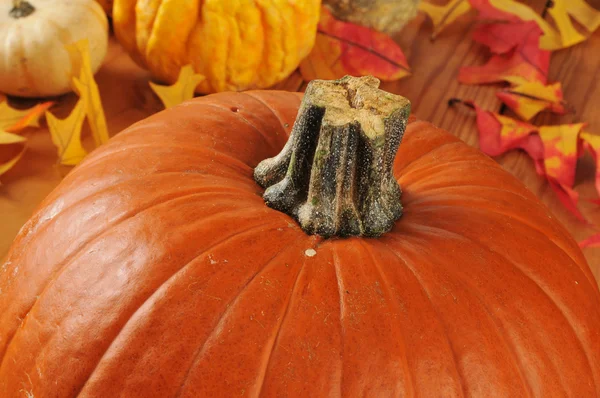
(0, 0, 108, 97)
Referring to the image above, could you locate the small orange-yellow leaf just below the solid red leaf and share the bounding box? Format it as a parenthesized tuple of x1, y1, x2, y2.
(496, 82, 567, 120)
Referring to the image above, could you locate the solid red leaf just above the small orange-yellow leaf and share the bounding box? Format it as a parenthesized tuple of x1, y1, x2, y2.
(458, 22, 550, 84)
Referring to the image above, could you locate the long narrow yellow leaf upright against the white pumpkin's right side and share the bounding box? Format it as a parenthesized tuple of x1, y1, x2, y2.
(65, 39, 109, 146)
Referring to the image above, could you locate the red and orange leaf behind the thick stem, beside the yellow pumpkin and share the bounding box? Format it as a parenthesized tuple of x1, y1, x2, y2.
(300, 7, 410, 81)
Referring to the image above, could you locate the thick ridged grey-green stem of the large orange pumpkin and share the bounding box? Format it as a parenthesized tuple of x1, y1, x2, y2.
(254, 76, 410, 237)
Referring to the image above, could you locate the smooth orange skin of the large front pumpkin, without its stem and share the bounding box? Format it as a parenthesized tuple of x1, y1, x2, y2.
(0, 91, 600, 397)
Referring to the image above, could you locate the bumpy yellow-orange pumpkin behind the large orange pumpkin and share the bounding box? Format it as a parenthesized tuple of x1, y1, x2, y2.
(112, 0, 321, 93)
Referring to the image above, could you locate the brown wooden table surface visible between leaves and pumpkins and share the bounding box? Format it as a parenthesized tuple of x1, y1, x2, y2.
(0, 0, 600, 280)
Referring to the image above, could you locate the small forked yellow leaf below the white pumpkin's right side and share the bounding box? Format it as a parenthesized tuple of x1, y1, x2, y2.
(46, 97, 87, 166)
